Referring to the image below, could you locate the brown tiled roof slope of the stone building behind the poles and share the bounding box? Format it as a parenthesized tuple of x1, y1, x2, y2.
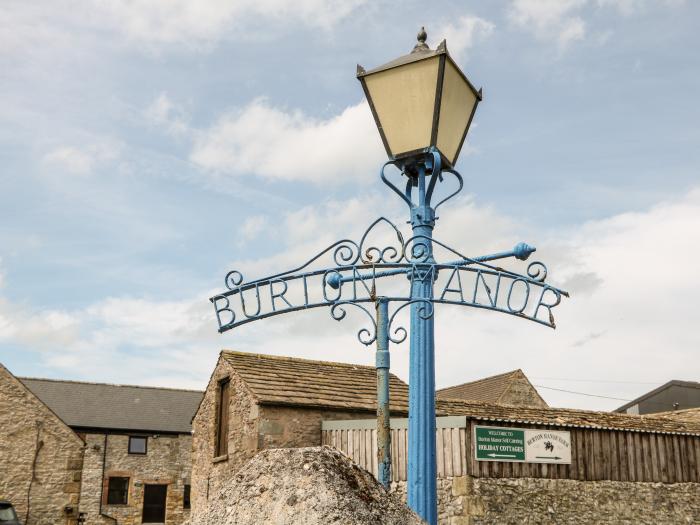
(221, 350, 408, 413)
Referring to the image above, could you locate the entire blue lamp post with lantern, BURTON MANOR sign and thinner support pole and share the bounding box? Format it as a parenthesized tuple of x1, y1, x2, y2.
(210, 25, 568, 525)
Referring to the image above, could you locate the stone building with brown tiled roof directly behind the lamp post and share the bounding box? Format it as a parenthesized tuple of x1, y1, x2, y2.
(192, 350, 408, 523)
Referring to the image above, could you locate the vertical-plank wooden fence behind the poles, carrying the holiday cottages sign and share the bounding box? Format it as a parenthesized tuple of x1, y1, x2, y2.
(322, 416, 700, 483)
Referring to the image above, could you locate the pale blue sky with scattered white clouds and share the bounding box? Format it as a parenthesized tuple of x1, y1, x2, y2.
(0, 0, 700, 410)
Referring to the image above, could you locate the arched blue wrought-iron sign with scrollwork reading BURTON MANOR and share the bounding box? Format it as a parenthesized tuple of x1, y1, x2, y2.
(210, 217, 568, 336)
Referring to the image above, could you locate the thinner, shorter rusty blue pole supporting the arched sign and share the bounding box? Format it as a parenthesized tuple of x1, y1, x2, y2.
(376, 297, 391, 490)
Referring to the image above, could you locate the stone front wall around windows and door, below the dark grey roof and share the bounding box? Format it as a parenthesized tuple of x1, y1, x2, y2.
(80, 433, 192, 525)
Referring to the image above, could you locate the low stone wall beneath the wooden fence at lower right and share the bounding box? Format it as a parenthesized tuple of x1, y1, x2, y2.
(392, 476, 700, 525)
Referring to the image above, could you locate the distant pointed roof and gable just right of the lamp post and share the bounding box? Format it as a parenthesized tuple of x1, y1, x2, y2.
(437, 369, 548, 408)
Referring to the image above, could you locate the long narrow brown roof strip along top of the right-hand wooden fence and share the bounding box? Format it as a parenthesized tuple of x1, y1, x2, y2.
(437, 399, 700, 435)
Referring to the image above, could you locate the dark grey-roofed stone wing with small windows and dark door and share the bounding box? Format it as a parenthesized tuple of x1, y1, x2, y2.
(20, 378, 202, 525)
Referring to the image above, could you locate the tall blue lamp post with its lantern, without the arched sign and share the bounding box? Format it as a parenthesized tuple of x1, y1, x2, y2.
(357, 28, 481, 525)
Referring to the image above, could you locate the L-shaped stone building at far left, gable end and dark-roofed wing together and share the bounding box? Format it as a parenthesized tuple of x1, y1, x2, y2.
(0, 360, 202, 525)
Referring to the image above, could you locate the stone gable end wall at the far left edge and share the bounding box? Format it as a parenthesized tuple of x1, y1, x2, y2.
(0, 365, 84, 525)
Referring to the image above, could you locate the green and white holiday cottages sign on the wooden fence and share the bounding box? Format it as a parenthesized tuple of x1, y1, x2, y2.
(474, 425, 571, 464)
